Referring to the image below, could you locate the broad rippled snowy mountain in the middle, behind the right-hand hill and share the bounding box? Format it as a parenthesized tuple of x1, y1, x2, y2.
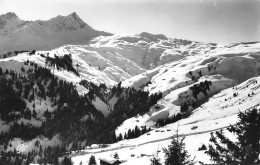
(0, 31, 219, 86)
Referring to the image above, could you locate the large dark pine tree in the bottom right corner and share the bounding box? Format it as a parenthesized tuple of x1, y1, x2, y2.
(205, 109, 260, 165)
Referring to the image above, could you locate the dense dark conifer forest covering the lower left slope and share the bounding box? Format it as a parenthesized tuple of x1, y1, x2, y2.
(0, 61, 162, 164)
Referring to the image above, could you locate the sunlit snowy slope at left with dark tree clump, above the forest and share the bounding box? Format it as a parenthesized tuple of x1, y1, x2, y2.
(0, 45, 145, 89)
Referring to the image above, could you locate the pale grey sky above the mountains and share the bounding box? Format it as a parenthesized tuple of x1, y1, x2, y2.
(0, 0, 260, 43)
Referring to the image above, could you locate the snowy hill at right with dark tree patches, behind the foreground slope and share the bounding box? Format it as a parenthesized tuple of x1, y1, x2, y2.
(122, 43, 260, 125)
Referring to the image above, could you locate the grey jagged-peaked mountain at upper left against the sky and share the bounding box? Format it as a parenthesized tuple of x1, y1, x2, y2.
(0, 13, 111, 53)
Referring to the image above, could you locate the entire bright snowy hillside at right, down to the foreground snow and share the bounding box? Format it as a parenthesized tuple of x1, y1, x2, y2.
(69, 43, 260, 165)
